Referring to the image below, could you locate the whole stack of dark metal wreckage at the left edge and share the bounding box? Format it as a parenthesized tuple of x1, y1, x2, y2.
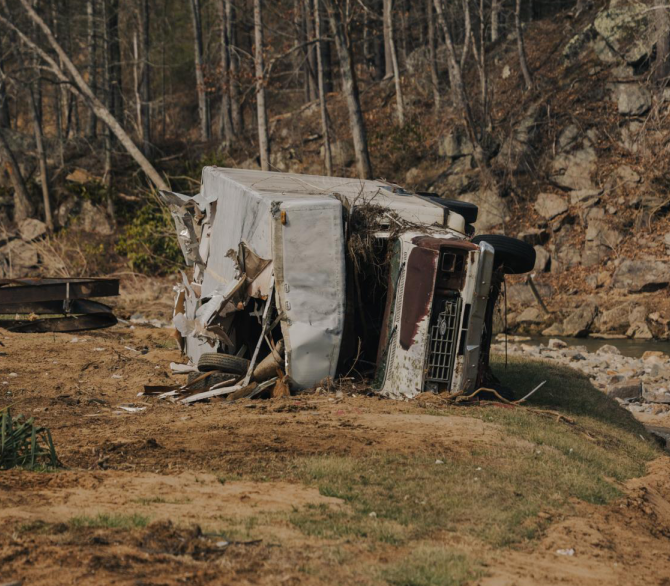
(0, 278, 119, 333)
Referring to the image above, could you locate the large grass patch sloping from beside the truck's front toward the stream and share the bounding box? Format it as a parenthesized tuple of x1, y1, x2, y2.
(290, 362, 659, 546)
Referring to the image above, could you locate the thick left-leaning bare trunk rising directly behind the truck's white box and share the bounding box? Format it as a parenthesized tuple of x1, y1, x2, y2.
(324, 0, 372, 179)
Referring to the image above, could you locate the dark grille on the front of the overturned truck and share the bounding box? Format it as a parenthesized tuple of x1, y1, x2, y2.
(426, 297, 461, 384)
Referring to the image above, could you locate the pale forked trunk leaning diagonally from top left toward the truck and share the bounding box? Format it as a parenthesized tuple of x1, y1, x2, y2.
(8, 0, 169, 190)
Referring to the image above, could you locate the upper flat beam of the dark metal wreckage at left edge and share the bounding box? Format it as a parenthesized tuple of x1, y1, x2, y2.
(0, 279, 119, 311)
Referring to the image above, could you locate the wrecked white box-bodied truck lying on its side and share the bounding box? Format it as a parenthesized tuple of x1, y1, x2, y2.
(162, 167, 535, 398)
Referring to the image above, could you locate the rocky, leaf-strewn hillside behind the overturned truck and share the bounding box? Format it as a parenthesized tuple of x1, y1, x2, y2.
(0, 0, 670, 339)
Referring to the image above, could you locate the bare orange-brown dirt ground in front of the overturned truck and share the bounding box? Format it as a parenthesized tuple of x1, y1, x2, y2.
(0, 324, 670, 586)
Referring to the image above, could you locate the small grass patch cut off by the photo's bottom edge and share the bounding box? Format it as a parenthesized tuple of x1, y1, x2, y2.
(382, 546, 481, 586)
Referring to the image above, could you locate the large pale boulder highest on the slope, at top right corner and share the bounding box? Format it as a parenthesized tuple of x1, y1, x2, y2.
(593, 1, 654, 64)
